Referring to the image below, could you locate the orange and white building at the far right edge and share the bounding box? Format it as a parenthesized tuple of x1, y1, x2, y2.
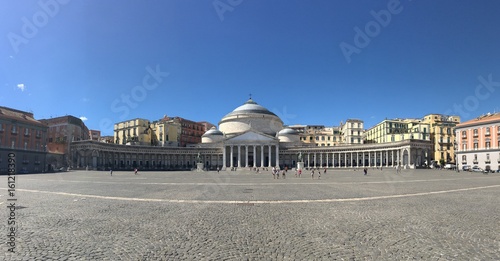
(455, 113, 500, 170)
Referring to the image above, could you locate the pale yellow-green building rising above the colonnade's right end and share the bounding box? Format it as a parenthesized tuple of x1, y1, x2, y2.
(364, 119, 430, 143)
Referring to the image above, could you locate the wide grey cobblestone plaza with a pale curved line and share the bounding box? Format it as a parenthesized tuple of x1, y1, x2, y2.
(0, 169, 500, 260)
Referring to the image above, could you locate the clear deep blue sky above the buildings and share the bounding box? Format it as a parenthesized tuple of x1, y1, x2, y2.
(0, 0, 500, 135)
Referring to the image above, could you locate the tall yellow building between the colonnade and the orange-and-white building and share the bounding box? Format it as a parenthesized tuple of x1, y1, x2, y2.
(423, 114, 460, 165)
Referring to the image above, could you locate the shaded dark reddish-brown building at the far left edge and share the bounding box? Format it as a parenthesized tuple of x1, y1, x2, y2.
(0, 107, 48, 174)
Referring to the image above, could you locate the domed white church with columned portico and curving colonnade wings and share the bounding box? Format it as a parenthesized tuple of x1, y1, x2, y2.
(72, 99, 431, 170)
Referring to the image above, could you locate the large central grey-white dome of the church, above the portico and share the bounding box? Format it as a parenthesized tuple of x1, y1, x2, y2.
(219, 98, 283, 136)
